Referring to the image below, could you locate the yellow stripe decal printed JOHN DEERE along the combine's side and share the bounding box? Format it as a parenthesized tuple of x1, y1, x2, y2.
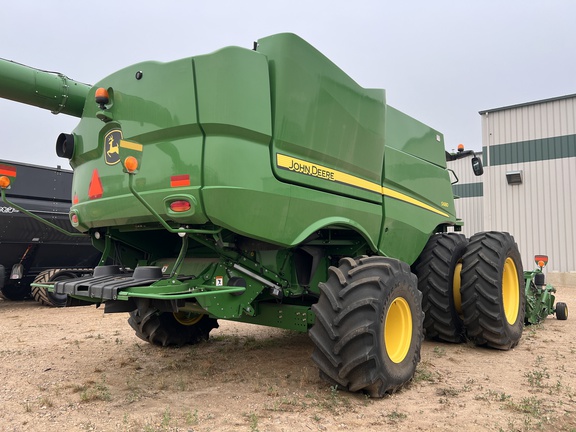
(276, 153, 450, 217)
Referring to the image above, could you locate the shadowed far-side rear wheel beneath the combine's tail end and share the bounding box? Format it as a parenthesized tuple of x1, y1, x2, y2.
(128, 308, 218, 346)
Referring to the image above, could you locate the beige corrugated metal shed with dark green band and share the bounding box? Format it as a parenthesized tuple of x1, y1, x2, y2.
(448, 95, 576, 284)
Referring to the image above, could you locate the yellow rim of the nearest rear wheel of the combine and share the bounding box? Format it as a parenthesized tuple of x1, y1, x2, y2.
(384, 297, 412, 363)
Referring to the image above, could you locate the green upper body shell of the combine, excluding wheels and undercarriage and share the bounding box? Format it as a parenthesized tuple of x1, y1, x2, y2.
(72, 35, 456, 263)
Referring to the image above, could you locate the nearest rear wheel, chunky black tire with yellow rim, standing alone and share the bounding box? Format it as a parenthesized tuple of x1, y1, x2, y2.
(309, 256, 423, 397)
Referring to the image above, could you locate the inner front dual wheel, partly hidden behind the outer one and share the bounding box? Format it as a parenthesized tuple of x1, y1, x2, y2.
(412, 233, 468, 343)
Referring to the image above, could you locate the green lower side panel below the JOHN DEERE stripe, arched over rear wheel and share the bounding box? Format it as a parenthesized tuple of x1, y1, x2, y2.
(203, 137, 382, 250)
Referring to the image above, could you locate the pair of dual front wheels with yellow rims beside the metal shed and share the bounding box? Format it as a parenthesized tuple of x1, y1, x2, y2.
(413, 231, 526, 350)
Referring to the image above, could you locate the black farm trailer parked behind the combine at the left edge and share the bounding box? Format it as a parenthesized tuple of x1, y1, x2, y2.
(0, 160, 100, 306)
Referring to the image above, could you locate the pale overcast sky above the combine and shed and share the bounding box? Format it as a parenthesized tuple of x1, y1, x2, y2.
(0, 0, 576, 168)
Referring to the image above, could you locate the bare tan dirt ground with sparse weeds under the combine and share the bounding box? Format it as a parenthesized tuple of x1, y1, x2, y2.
(0, 287, 576, 432)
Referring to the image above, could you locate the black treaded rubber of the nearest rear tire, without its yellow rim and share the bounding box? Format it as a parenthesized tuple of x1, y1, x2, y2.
(309, 256, 423, 397)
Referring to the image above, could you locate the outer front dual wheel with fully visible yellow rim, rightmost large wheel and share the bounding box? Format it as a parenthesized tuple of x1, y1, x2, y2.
(460, 231, 526, 350)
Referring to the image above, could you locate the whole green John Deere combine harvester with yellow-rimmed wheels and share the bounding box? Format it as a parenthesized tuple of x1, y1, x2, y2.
(0, 34, 525, 397)
